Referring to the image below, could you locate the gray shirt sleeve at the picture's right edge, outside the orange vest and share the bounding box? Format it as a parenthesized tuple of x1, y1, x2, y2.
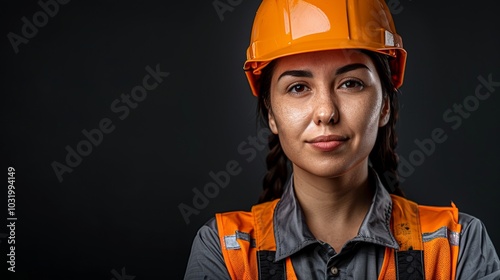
(456, 213, 500, 280)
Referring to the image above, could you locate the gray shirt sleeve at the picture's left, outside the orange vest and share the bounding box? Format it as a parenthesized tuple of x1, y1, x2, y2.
(184, 218, 231, 280)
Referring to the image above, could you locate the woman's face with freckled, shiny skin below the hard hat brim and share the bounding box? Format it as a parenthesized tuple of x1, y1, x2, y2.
(269, 50, 390, 177)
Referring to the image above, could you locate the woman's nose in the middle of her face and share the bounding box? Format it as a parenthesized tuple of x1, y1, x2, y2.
(314, 89, 339, 125)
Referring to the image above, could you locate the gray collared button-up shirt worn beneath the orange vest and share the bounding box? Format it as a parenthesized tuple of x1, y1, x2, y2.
(184, 172, 500, 280)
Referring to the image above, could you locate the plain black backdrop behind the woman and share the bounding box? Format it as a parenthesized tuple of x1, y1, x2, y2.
(0, 0, 500, 280)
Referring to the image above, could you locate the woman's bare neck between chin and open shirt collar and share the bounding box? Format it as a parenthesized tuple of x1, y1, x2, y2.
(294, 166, 373, 251)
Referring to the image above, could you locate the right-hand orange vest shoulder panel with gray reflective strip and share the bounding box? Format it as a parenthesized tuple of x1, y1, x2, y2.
(379, 195, 461, 280)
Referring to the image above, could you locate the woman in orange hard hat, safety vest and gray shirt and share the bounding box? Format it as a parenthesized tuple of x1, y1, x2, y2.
(185, 0, 500, 279)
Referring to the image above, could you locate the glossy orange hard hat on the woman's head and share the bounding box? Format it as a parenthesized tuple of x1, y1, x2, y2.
(243, 0, 406, 96)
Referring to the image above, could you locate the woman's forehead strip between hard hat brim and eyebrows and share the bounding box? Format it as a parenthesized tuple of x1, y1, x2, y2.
(275, 49, 375, 73)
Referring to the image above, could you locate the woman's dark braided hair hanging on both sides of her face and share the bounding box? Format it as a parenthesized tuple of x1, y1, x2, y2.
(257, 50, 404, 203)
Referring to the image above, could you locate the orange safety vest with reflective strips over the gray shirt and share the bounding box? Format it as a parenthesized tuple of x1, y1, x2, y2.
(216, 194, 461, 280)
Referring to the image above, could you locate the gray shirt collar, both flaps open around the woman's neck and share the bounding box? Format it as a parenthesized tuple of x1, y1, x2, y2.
(273, 168, 399, 260)
